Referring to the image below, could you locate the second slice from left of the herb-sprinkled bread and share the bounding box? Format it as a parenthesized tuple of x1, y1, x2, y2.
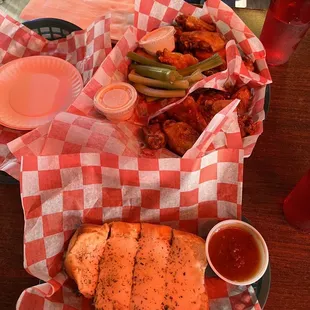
(95, 222, 140, 310)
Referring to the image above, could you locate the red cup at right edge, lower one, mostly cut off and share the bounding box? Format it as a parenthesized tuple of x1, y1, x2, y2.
(283, 170, 310, 232)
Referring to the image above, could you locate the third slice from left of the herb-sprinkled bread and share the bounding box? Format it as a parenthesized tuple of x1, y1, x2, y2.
(130, 224, 172, 310)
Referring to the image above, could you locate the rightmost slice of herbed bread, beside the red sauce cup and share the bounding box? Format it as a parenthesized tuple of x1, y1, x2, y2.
(162, 230, 209, 310)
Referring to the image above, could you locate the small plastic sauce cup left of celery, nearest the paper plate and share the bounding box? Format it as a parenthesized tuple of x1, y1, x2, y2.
(94, 82, 138, 122)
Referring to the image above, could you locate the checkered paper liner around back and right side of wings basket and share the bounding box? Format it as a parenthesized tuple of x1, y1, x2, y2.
(69, 0, 271, 156)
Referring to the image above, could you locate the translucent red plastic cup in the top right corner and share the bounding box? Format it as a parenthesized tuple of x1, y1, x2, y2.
(260, 0, 310, 66)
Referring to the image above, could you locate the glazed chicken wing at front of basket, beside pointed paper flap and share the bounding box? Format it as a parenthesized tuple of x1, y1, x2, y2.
(163, 120, 199, 156)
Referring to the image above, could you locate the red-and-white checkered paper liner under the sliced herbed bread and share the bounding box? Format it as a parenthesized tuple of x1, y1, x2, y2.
(17, 149, 259, 310)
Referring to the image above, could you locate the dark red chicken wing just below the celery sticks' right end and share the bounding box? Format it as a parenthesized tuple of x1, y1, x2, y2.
(167, 96, 207, 133)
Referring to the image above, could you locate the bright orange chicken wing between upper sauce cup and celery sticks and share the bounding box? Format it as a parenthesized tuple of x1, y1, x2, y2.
(157, 48, 198, 69)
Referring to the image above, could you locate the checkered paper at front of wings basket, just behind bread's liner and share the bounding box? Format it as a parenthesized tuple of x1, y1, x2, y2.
(9, 93, 242, 161)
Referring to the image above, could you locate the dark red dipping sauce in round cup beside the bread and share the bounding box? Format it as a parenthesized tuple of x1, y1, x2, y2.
(209, 227, 262, 282)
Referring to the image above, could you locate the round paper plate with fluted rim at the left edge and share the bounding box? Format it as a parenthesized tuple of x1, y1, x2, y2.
(0, 56, 83, 130)
